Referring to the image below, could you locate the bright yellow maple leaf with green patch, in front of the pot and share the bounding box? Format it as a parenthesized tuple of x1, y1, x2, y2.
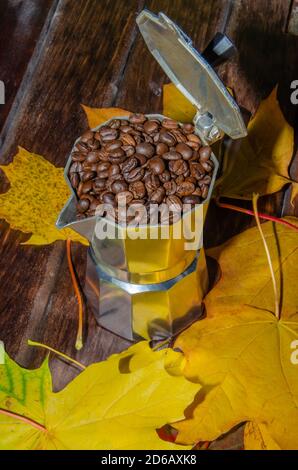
(0, 341, 198, 450)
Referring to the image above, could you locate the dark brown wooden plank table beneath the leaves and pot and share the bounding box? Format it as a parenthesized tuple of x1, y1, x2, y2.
(0, 0, 298, 447)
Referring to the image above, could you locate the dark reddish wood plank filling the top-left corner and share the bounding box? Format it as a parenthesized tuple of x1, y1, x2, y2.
(0, 0, 58, 130)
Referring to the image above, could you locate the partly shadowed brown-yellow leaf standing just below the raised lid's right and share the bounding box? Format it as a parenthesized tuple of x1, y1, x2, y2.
(215, 89, 298, 200)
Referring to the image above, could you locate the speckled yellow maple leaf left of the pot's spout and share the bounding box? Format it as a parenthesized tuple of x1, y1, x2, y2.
(0, 147, 87, 245)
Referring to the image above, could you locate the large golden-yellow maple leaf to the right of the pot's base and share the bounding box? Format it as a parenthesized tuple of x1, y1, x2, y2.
(175, 218, 298, 449)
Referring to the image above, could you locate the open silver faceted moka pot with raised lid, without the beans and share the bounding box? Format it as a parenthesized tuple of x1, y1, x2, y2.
(56, 10, 246, 341)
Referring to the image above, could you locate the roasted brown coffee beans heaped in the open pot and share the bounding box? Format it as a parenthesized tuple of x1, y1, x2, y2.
(69, 114, 214, 223)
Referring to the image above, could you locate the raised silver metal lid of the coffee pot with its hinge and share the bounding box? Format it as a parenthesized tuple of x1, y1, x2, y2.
(137, 10, 247, 142)
